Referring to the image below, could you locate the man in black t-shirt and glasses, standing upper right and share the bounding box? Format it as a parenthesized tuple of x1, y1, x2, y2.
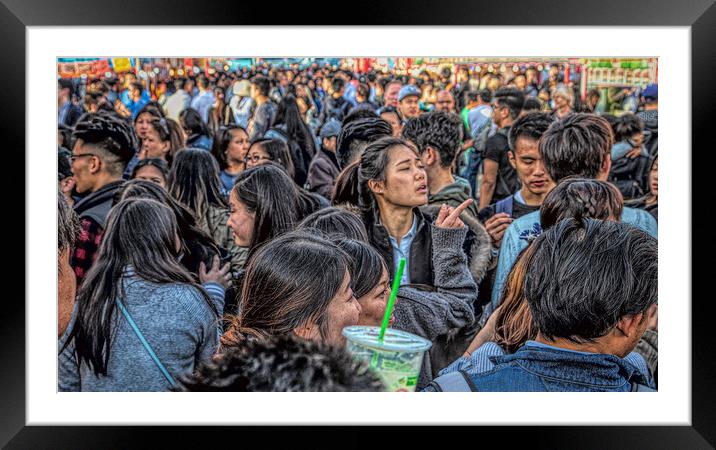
(480, 88, 525, 209)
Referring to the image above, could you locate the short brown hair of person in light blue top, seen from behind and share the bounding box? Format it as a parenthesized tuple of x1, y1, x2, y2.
(539, 113, 614, 183)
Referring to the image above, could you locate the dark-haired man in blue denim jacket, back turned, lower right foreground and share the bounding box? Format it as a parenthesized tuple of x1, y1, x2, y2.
(450, 219, 658, 392)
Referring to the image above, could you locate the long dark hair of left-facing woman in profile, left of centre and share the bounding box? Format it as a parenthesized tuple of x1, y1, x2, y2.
(231, 164, 299, 257)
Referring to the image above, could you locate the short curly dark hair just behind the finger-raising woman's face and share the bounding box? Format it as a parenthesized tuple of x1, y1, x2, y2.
(402, 111, 463, 167)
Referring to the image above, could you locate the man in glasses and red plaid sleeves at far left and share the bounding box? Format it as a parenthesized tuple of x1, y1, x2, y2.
(70, 115, 137, 286)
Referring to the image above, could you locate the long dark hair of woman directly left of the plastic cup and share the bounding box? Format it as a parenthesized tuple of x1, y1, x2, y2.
(221, 232, 352, 346)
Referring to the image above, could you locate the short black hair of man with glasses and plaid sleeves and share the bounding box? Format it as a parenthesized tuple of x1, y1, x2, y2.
(72, 113, 139, 175)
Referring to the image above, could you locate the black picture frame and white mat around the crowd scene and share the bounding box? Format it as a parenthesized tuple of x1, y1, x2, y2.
(5, 0, 716, 448)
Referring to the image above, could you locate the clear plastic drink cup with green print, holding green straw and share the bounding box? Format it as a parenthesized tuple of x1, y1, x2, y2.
(343, 326, 433, 391)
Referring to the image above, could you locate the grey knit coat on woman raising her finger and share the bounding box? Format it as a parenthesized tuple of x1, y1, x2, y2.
(393, 225, 477, 390)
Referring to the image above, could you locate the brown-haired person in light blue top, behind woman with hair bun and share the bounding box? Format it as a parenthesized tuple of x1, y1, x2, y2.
(490, 113, 657, 310)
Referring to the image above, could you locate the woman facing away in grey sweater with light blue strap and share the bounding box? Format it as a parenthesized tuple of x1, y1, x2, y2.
(58, 199, 224, 392)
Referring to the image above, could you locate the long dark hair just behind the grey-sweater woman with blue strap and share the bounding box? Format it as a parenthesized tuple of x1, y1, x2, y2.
(115, 180, 221, 280)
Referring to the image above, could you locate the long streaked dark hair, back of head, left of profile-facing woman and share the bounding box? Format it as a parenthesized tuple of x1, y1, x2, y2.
(167, 148, 227, 219)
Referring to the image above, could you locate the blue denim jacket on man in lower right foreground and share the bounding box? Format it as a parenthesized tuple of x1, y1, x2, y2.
(470, 341, 648, 392)
